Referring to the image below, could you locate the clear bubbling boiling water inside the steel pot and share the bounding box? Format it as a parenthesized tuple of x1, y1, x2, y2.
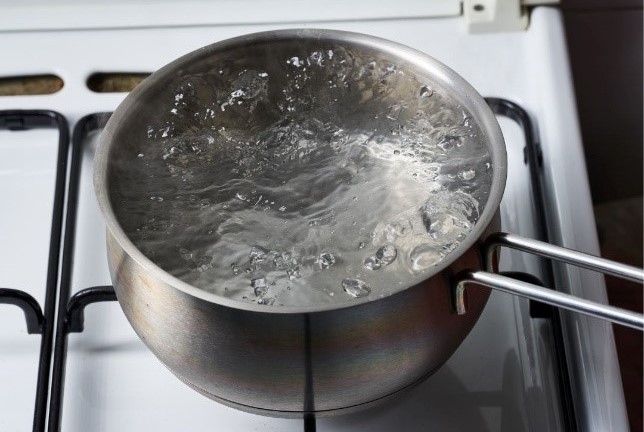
(112, 47, 492, 306)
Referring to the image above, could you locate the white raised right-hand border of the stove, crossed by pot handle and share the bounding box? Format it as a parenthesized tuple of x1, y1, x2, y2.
(529, 13, 628, 431)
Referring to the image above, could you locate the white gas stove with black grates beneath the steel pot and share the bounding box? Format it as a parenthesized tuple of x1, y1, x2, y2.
(0, 4, 628, 432)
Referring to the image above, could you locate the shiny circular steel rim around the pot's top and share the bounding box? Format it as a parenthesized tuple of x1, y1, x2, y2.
(94, 29, 507, 314)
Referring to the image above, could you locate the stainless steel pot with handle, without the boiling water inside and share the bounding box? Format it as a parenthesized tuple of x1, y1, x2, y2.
(94, 30, 643, 417)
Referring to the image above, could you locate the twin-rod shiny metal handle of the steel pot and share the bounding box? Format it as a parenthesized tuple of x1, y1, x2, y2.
(453, 232, 644, 331)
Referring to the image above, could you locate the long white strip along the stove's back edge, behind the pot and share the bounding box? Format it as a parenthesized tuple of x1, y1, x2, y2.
(0, 0, 461, 31)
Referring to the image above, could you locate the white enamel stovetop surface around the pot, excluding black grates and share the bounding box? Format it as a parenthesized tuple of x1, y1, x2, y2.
(0, 8, 625, 432)
